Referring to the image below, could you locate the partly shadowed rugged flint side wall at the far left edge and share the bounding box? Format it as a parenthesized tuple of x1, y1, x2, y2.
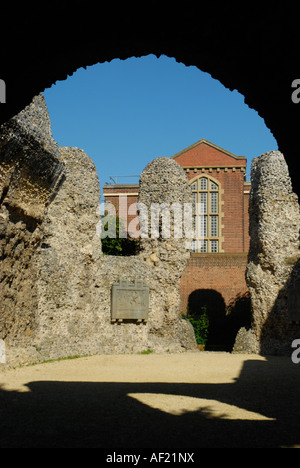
(0, 96, 63, 360)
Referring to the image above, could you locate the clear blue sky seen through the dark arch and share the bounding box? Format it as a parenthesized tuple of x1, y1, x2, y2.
(43, 55, 278, 197)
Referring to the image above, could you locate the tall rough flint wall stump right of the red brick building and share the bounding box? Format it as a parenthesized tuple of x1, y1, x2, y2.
(239, 151, 300, 354)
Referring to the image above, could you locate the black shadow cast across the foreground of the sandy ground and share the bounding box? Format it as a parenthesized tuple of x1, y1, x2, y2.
(0, 357, 300, 449)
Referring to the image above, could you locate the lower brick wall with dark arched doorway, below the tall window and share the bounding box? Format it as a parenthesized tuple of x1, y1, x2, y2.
(180, 253, 251, 352)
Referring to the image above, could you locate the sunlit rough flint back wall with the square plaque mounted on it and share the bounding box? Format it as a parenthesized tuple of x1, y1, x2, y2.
(34, 148, 195, 358)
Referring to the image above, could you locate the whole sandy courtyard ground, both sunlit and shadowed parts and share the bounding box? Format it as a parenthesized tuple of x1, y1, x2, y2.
(0, 351, 300, 449)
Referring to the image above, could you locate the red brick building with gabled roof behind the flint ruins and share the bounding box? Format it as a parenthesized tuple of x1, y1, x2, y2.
(103, 139, 250, 345)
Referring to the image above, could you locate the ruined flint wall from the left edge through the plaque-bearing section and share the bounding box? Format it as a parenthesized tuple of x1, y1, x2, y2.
(0, 96, 196, 365)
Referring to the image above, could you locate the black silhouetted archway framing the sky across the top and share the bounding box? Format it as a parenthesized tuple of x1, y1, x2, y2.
(0, 0, 300, 194)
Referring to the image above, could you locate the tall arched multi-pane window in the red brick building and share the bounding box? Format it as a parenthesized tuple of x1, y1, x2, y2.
(190, 176, 220, 253)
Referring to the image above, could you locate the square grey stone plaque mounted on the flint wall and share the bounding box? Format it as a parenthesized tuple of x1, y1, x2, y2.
(111, 280, 149, 322)
